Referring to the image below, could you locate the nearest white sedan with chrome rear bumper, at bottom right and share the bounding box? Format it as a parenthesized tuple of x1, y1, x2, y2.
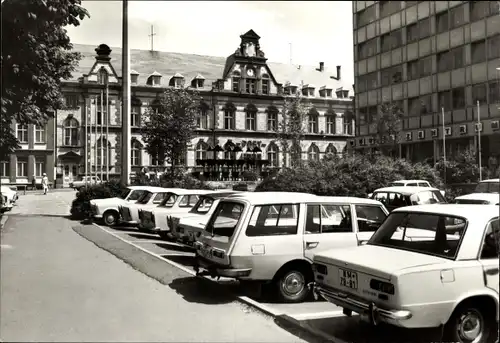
(314, 204, 500, 343)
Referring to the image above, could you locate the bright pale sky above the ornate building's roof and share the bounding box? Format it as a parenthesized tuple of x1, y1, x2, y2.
(68, 0, 353, 83)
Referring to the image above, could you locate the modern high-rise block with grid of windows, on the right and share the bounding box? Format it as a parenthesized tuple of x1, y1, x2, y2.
(351, 1, 500, 166)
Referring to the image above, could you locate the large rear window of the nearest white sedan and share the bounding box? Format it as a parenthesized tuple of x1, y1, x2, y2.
(367, 212, 467, 259)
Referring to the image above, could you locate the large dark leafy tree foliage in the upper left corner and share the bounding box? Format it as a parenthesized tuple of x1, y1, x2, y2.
(0, 0, 89, 159)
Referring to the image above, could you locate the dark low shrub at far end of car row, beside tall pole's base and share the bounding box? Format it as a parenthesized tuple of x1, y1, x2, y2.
(70, 181, 124, 220)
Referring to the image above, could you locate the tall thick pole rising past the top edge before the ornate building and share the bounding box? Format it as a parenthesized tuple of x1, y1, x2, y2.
(121, 0, 130, 185)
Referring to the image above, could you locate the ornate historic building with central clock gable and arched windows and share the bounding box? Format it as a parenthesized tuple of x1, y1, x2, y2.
(0, 30, 354, 184)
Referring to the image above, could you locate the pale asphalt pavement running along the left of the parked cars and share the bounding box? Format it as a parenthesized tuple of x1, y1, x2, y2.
(0, 193, 303, 342)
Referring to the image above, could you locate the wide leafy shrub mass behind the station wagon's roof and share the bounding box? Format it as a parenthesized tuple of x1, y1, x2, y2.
(255, 155, 442, 197)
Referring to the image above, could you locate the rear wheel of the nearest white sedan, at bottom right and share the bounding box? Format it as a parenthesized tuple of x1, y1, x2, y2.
(444, 301, 495, 343)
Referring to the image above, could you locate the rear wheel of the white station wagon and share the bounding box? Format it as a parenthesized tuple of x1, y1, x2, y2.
(275, 266, 311, 303)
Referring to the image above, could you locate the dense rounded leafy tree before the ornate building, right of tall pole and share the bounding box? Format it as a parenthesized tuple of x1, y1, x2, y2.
(142, 88, 200, 178)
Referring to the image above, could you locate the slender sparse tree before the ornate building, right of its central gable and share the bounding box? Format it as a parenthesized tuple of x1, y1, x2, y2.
(276, 93, 309, 167)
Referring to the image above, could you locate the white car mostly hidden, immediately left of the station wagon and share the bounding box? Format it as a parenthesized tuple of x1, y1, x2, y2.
(168, 191, 242, 244)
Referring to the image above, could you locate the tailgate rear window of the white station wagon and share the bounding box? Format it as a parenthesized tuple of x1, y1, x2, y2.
(206, 201, 243, 241)
